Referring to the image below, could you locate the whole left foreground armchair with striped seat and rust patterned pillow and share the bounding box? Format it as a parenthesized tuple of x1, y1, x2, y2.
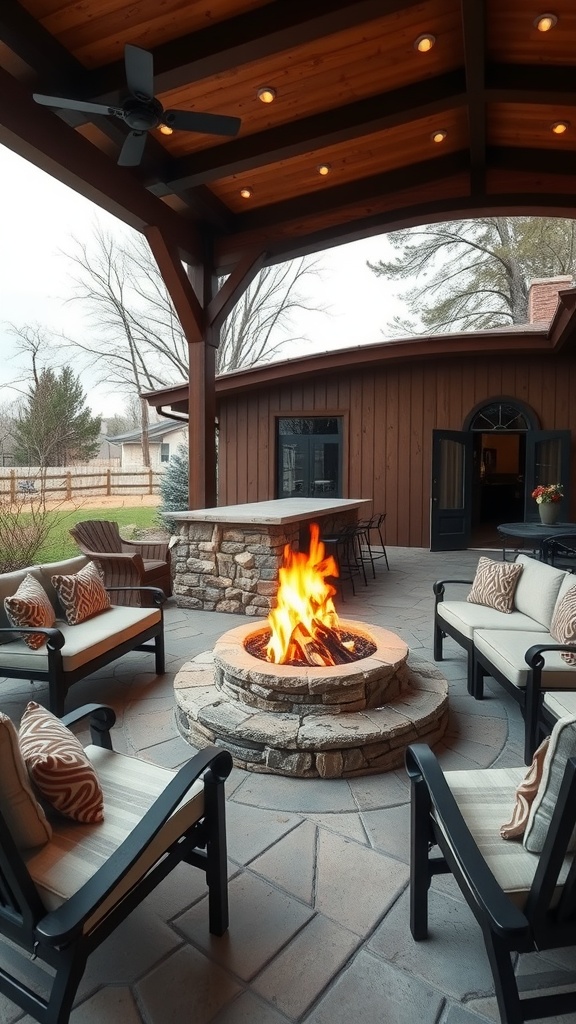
(0, 702, 232, 1024)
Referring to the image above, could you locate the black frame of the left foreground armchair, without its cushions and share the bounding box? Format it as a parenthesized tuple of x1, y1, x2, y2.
(0, 705, 232, 1024)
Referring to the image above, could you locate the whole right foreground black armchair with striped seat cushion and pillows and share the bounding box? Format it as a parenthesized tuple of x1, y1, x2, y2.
(406, 716, 576, 1024)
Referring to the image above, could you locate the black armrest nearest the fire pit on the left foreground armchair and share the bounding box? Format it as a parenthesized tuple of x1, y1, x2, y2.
(37, 746, 232, 945)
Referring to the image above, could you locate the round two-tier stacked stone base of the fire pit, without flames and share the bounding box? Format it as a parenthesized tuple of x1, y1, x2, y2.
(174, 628, 448, 778)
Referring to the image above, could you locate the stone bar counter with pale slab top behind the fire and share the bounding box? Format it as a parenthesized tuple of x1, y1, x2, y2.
(171, 498, 370, 617)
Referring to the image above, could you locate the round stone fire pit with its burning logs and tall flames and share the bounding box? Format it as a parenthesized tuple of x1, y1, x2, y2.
(175, 526, 448, 778)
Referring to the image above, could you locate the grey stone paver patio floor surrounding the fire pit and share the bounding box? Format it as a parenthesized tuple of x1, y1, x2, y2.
(0, 548, 576, 1024)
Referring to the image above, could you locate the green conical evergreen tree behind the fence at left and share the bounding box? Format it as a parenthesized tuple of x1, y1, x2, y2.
(14, 367, 100, 467)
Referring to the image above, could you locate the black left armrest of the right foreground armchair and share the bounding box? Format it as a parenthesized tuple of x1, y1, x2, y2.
(406, 743, 530, 937)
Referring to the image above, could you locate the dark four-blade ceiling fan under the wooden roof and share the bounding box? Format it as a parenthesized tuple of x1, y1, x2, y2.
(33, 44, 242, 167)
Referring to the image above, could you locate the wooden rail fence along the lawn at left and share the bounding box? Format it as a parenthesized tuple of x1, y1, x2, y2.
(0, 466, 163, 502)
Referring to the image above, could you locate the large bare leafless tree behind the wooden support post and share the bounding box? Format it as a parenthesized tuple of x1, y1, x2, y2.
(58, 226, 320, 465)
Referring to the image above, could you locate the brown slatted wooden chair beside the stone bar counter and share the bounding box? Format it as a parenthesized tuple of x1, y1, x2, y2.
(70, 519, 172, 606)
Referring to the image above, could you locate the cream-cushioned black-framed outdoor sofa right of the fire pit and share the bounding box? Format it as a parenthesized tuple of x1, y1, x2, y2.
(434, 555, 576, 764)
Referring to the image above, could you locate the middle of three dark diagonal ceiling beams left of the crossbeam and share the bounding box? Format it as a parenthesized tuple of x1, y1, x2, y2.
(163, 71, 466, 188)
